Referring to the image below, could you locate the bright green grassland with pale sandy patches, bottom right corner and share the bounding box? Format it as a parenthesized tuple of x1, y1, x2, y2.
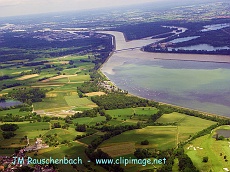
(184, 126, 230, 172)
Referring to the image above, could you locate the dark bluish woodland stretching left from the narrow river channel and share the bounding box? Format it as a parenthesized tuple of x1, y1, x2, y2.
(0, 32, 113, 62)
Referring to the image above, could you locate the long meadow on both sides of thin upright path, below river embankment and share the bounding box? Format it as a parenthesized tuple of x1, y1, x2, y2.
(100, 112, 215, 157)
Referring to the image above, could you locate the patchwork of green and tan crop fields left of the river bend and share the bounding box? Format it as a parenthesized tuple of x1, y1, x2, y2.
(0, 55, 96, 116)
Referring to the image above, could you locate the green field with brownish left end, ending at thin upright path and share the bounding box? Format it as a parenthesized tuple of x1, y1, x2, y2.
(100, 126, 177, 155)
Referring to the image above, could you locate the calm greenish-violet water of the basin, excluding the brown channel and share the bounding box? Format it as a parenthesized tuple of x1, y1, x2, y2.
(107, 59, 230, 116)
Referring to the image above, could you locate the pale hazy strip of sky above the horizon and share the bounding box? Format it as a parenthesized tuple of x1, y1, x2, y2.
(0, 0, 225, 17)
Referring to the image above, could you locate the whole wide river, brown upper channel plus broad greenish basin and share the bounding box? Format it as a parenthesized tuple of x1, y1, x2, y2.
(101, 31, 230, 117)
